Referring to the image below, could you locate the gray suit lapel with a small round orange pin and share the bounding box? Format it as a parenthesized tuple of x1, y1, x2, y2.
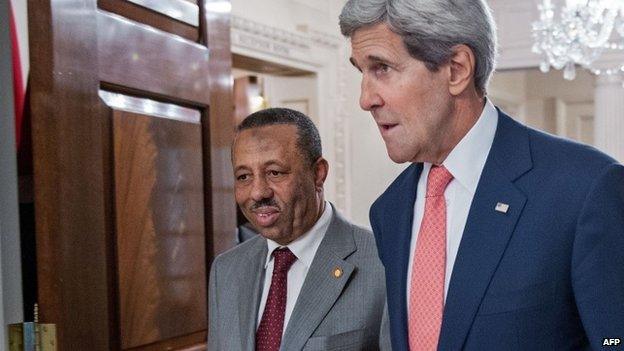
(281, 209, 356, 350)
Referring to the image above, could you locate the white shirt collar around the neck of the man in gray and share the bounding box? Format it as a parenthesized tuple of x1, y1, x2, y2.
(264, 201, 333, 269)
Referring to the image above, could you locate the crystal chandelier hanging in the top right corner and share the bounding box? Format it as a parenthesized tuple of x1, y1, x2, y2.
(533, 0, 624, 80)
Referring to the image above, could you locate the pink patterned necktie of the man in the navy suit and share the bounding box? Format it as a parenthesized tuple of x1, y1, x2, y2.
(408, 166, 453, 351)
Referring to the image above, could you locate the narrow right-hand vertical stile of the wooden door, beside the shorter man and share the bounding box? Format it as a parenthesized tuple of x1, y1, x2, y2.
(200, 0, 236, 259)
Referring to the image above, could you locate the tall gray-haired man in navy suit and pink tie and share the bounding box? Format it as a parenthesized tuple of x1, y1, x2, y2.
(340, 0, 624, 351)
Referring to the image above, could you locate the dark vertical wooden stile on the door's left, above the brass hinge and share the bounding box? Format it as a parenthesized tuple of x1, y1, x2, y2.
(28, 0, 116, 351)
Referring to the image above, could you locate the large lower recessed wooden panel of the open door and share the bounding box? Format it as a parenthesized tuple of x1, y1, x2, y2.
(113, 111, 206, 349)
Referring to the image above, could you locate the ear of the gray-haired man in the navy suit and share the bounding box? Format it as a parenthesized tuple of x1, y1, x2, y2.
(449, 44, 476, 96)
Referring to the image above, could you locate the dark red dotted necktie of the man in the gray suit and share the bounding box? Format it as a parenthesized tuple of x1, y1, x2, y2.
(256, 248, 297, 351)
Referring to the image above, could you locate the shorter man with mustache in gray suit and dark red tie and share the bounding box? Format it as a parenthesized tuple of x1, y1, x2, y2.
(208, 108, 387, 351)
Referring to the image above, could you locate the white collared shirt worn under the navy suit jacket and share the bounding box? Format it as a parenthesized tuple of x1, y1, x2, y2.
(407, 100, 498, 308)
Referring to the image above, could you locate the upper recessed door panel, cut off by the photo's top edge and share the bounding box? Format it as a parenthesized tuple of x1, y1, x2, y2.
(98, 0, 200, 42)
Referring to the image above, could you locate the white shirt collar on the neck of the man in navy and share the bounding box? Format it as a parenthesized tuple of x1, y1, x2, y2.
(442, 98, 498, 195)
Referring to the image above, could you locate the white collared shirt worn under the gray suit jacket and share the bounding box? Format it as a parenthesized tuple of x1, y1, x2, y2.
(256, 201, 333, 333)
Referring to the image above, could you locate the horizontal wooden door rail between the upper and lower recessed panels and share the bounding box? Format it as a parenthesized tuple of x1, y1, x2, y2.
(97, 11, 210, 105)
